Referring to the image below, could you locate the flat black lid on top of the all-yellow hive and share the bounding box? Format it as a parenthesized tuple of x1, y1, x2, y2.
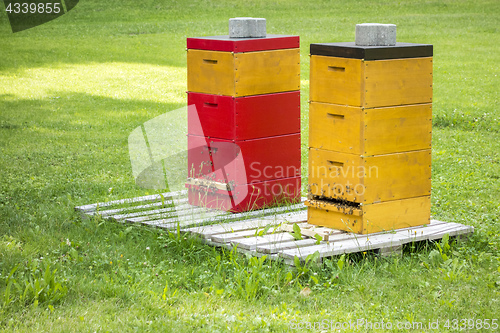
(310, 42, 433, 60)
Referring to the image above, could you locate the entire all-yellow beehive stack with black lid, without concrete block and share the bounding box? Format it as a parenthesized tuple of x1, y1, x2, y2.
(306, 26, 432, 234)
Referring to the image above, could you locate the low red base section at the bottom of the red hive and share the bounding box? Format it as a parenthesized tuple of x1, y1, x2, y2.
(187, 177, 301, 213)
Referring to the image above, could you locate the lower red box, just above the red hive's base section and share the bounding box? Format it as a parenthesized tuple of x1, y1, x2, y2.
(188, 133, 301, 184)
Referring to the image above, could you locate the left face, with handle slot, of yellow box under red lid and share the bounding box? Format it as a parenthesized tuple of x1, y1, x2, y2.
(187, 49, 235, 96)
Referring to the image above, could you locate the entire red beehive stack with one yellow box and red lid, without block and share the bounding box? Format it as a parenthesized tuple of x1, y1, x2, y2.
(186, 23, 301, 212)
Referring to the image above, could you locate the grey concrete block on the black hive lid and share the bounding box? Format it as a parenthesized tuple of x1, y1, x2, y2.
(355, 23, 396, 46)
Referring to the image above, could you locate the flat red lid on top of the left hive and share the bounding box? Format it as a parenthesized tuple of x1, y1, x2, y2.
(187, 34, 300, 53)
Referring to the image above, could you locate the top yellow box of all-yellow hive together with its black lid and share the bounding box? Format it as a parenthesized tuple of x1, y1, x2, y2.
(310, 43, 432, 108)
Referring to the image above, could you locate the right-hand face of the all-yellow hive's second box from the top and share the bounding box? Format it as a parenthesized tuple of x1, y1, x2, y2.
(362, 104, 432, 155)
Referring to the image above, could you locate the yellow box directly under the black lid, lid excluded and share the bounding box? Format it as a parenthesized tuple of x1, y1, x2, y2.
(310, 55, 432, 108)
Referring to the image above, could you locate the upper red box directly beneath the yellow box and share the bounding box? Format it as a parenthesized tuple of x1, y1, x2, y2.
(188, 91, 300, 140)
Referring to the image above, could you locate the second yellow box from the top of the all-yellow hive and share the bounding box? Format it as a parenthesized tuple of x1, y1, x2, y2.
(309, 102, 432, 156)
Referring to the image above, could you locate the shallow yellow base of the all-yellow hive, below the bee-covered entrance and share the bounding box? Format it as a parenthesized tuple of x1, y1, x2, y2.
(305, 196, 431, 234)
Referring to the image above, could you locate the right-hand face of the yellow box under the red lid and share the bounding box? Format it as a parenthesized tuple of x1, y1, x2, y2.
(234, 48, 300, 96)
